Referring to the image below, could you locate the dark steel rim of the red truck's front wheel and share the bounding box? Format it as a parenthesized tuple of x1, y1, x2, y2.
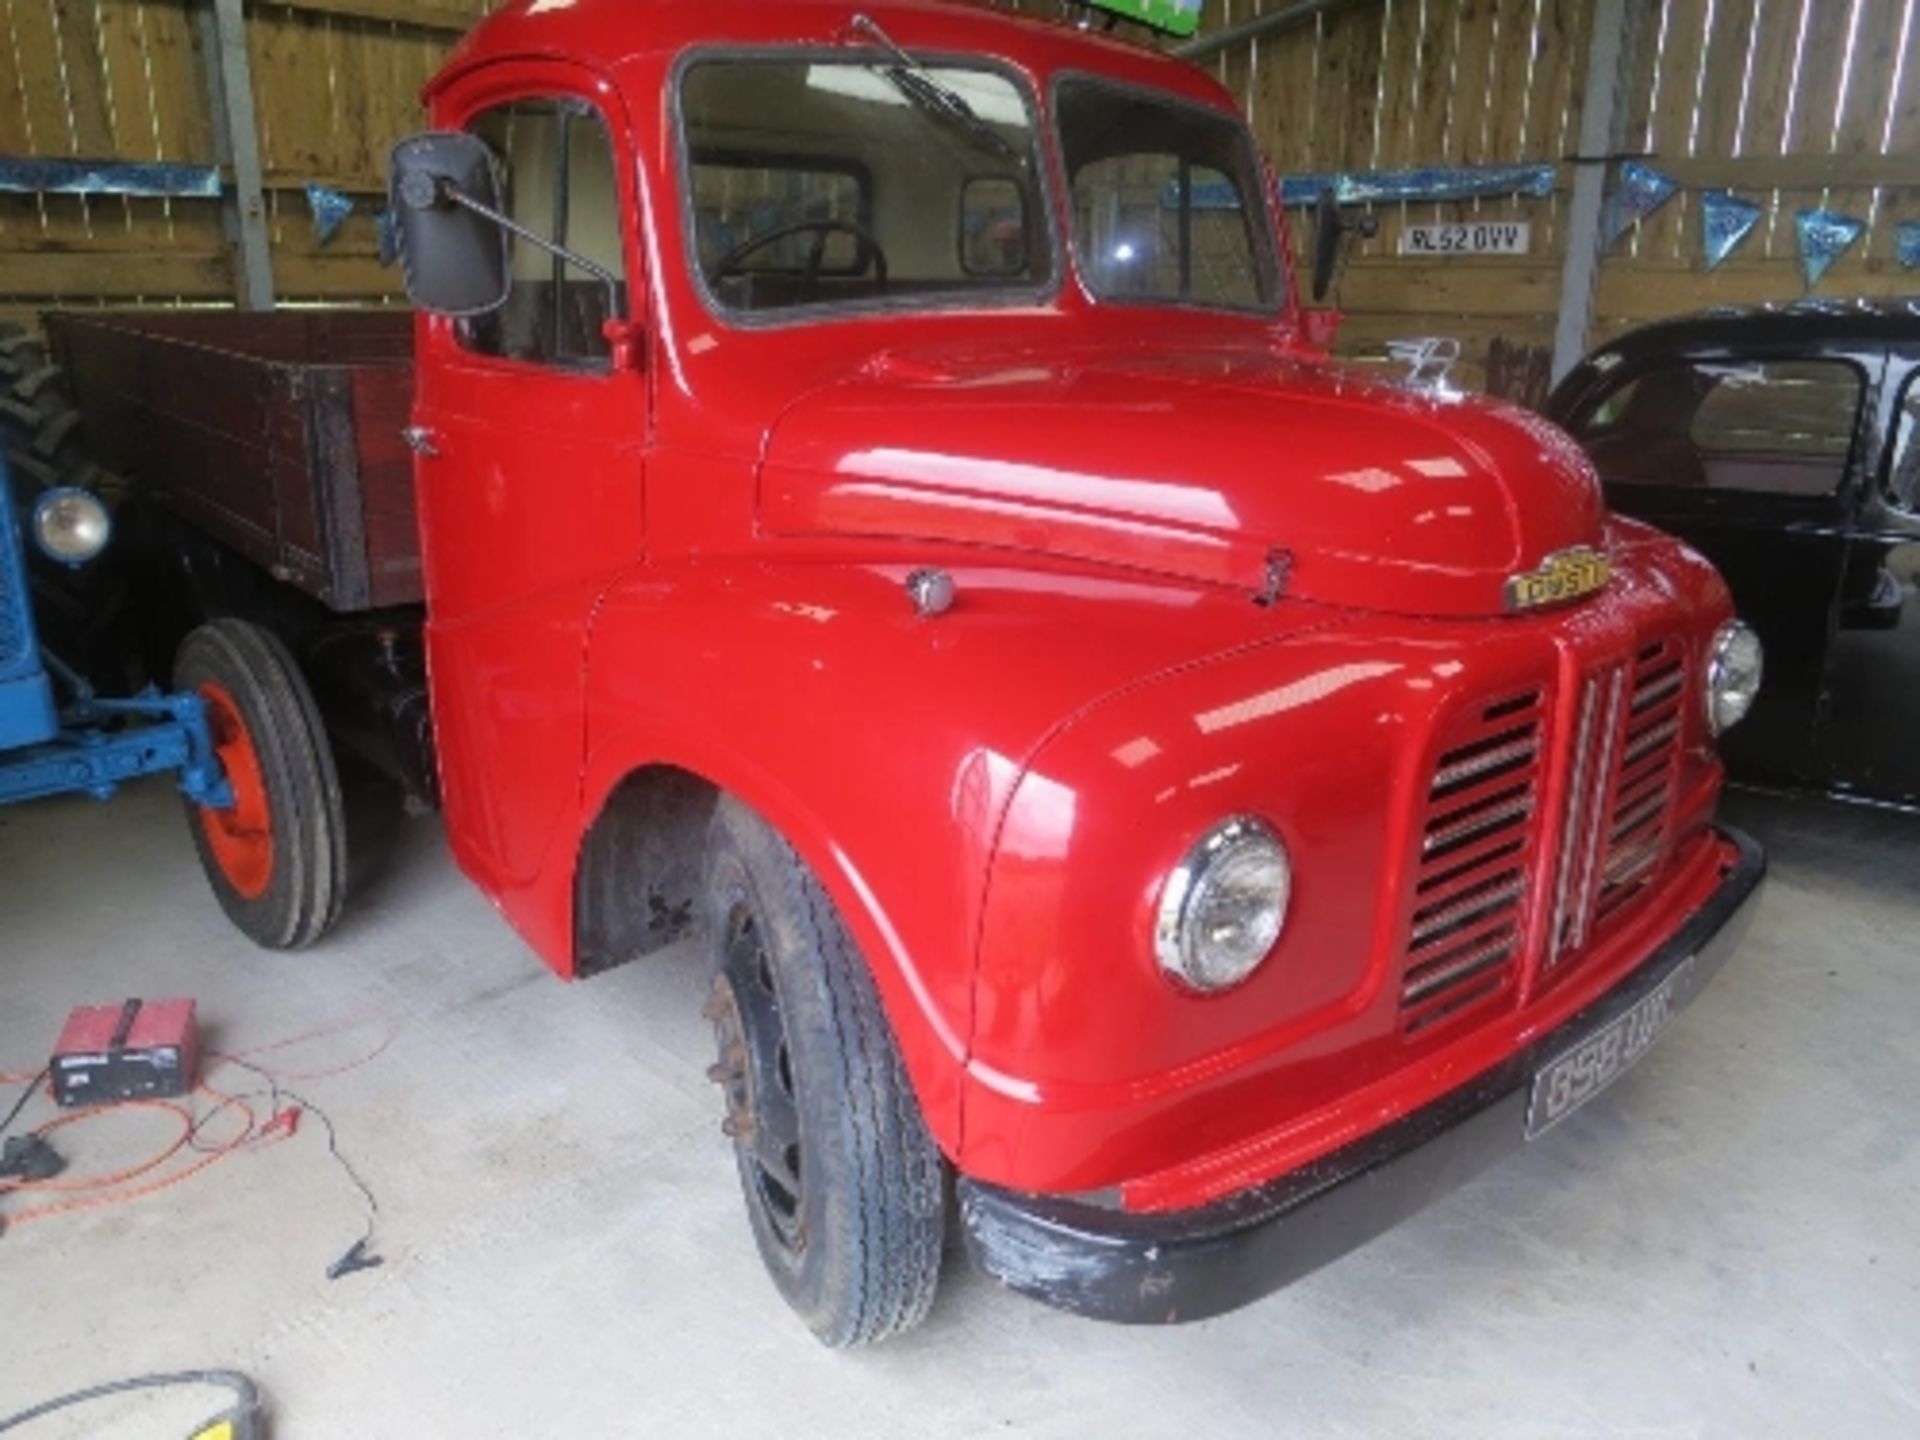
(708, 899, 806, 1256)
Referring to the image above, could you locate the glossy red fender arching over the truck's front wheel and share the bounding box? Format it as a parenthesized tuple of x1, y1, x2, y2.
(582, 559, 1300, 1154)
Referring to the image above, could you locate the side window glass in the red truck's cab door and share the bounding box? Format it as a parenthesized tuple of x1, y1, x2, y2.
(459, 100, 626, 371)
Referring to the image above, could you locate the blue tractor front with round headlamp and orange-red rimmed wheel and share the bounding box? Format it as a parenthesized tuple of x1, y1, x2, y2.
(0, 451, 346, 948)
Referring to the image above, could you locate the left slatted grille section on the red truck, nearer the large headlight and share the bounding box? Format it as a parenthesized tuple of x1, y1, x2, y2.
(1400, 689, 1544, 1031)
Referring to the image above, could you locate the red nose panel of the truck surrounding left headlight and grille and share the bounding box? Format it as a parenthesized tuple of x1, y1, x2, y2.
(962, 528, 1728, 1192)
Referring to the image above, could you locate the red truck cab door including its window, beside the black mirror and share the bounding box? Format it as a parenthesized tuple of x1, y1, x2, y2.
(415, 73, 647, 906)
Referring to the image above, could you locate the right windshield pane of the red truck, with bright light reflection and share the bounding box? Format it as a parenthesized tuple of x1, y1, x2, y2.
(1058, 79, 1281, 311)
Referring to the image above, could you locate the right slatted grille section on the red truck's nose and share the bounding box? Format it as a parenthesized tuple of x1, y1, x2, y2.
(1542, 639, 1688, 972)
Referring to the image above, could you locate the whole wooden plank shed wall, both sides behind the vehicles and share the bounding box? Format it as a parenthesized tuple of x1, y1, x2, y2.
(0, 0, 1920, 390)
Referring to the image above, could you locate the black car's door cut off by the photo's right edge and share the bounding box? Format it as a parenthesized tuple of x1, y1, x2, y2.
(1820, 348, 1920, 804)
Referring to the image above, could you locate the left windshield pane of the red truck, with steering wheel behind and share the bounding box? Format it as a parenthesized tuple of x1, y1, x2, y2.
(680, 56, 1052, 313)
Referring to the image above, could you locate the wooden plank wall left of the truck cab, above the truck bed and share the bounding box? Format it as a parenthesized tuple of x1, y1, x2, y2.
(0, 0, 486, 328)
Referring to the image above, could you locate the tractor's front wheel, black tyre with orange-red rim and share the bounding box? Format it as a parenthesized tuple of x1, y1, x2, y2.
(173, 620, 348, 950)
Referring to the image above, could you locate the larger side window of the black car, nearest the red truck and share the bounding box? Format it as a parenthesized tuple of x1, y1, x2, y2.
(1574, 359, 1862, 497)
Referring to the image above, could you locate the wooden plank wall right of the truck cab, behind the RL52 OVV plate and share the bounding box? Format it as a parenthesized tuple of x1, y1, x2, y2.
(1202, 0, 1920, 401)
